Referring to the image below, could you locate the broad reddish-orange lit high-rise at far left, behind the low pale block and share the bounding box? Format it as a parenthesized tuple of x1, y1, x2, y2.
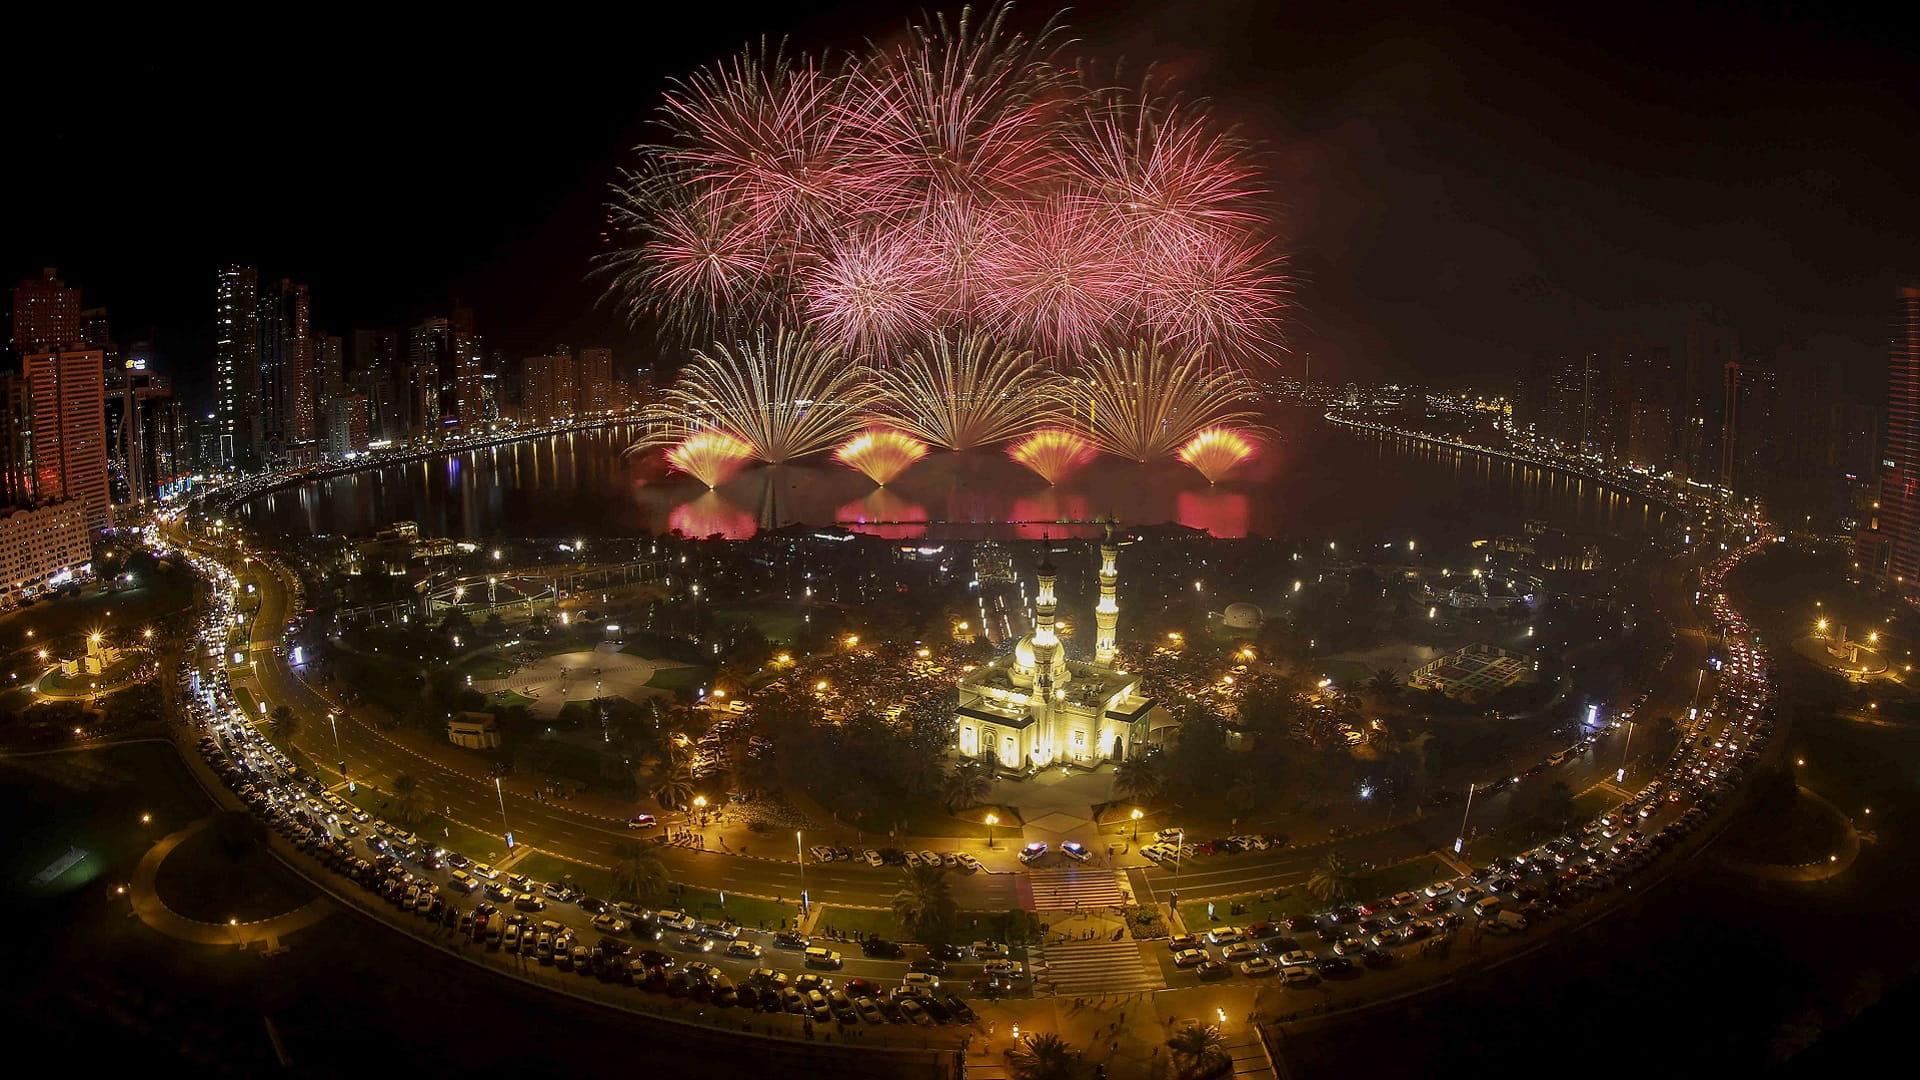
(21, 350, 113, 530)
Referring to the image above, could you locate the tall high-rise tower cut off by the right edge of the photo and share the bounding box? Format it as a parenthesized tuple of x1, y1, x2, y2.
(1855, 284, 1920, 600)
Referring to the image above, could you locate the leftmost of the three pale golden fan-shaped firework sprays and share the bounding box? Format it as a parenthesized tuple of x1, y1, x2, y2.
(636, 331, 879, 465)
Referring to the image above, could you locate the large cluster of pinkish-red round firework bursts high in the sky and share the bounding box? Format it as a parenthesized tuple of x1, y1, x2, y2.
(603, 8, 1283, 363)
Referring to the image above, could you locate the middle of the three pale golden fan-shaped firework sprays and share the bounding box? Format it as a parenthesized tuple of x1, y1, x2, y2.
(877, 334, 1052, 450)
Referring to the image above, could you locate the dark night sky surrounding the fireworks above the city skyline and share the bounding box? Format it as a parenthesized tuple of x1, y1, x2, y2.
(0, 0, 1920, 405)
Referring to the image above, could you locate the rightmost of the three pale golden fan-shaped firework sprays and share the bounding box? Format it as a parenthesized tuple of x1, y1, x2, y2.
(1066, 346, 1254, 461)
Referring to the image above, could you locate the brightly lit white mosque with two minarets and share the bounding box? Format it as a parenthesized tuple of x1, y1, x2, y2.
(954, 528, 1167, 769)
